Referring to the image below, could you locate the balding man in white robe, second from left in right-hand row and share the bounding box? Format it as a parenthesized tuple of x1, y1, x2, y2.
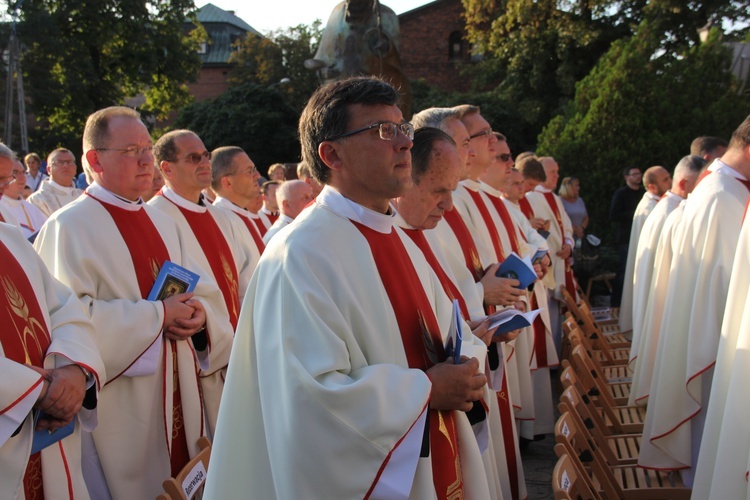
(630, 155, 706, 392)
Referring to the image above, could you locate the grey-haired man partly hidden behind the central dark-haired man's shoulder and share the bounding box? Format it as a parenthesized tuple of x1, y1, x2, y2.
(211, 146, 266, 254)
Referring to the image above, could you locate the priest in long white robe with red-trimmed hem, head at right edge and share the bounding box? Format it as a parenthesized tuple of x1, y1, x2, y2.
(638, 117, 750, 486)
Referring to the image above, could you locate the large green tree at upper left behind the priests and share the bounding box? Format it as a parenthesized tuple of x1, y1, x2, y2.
(19, 0, 205, 150)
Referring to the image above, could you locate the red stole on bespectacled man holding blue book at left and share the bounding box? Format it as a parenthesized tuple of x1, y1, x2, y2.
(86, 192, 190, 476)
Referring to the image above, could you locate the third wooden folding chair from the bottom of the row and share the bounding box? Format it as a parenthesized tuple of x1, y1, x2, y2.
(557, 387, 642, 465)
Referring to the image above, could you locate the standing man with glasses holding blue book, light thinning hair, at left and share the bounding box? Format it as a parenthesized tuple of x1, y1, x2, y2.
(35, 107, 227, 498)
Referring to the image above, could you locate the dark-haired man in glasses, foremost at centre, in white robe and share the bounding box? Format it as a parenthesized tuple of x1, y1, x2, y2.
(212, 77, 489, 498)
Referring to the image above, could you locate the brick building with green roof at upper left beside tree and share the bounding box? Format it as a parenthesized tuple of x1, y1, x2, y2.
(186, 3, 261, 102)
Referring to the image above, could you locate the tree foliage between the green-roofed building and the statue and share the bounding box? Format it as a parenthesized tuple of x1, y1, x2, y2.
(230, 21, 322, 111)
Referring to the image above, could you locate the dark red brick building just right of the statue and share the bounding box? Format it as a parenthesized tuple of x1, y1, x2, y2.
(396, 0, 471, 90)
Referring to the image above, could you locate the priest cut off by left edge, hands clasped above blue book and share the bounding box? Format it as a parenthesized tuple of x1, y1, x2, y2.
(0, 144, 104, 499)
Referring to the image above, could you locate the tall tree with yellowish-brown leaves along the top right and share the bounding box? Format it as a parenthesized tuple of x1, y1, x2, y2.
(463, 0, 750, 145)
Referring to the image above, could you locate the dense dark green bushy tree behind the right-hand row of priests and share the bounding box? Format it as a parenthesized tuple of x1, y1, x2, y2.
(538, 21, 750, 240)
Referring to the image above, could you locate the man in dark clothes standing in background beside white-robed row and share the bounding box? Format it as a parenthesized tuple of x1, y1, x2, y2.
(609, 167, 646, 308)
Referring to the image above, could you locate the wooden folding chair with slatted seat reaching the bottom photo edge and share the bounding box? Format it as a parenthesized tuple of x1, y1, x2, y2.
(555, 412, 691, 500)
